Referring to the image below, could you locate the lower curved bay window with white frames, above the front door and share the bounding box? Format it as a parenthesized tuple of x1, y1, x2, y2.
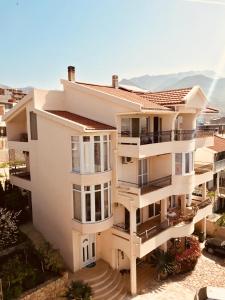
(73, 182, 111, 223)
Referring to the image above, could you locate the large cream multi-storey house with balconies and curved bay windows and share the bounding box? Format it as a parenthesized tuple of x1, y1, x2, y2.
(4, 67, 214, 294)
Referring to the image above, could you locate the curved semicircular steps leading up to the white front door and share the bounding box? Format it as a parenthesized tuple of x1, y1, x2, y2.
(71, 260, 127, 300)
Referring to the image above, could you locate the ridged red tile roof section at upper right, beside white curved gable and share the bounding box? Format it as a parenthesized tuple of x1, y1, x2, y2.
(136, 87, 192, 107)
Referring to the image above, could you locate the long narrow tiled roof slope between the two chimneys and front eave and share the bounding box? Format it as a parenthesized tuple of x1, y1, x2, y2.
(76, 82, 169, 110)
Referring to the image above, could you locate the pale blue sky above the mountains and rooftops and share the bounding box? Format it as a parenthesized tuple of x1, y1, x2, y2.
(0, 0, 225, 88)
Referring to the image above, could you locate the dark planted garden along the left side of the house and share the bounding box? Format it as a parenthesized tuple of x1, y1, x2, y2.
(0, 181, 64, 300)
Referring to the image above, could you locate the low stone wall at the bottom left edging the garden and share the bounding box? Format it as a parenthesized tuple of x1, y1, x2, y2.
(19, 272, 68, 300)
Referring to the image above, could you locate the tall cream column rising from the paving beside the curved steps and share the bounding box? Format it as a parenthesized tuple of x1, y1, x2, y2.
(130, 203, 137, 295)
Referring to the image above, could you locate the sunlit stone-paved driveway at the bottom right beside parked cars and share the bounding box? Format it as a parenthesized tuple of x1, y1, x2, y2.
(130, 250, 225, 300)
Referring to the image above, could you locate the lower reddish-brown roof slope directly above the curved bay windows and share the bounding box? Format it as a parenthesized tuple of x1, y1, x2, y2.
(46, 110, 115, 130)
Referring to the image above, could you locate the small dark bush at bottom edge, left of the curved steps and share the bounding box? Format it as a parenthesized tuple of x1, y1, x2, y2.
(65, 281, 92, 300)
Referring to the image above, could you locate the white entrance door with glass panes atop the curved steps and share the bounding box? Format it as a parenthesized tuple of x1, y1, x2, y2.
(81, 234, 96, 267)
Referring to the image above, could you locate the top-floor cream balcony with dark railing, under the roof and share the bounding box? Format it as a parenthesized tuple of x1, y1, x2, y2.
(118, 130, 214, 158)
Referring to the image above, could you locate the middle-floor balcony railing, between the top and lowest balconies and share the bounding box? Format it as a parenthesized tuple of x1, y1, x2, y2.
(119, 175, 172, 195)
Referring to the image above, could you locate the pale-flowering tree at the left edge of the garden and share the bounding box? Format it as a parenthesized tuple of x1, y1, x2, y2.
(0, 208, 20, 250)
